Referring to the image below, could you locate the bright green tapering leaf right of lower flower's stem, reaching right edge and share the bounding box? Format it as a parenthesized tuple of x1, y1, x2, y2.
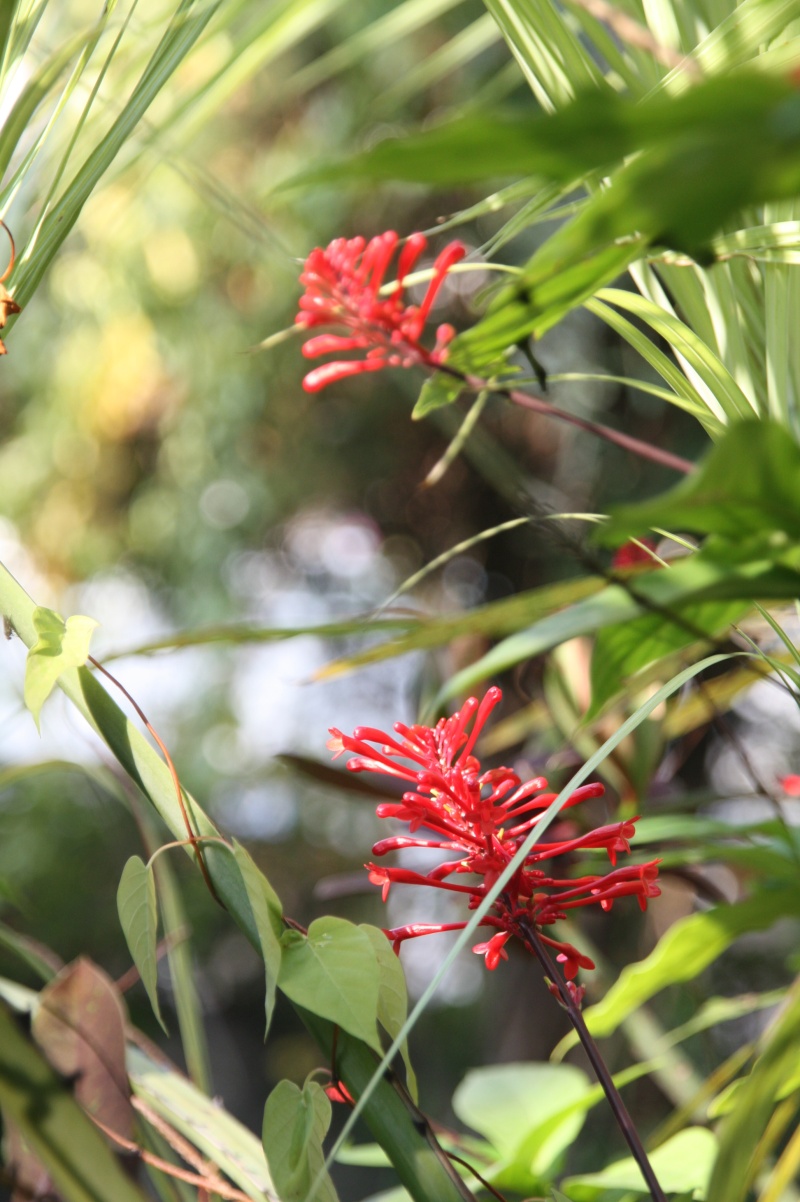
(560, 885, 800, 1048)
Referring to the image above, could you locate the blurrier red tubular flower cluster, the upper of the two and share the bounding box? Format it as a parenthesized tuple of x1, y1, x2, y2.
(295, 230, 466, 392)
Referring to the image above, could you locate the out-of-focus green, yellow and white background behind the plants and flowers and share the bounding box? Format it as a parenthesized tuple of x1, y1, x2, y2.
(0, 0, 798, 1196)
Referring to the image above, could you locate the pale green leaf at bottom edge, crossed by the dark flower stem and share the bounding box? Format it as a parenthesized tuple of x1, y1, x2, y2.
(563, 1127, 715, 1202)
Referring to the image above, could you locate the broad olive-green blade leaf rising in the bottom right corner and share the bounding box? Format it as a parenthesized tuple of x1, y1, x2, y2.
(706, 987, 800, 1202)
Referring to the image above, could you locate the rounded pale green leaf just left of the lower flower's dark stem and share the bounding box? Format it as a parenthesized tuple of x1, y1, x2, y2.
(453, 1064, 591, 1194)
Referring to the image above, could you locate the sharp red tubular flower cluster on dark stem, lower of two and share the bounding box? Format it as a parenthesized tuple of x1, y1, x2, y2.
(328, 689, 661, 995)
